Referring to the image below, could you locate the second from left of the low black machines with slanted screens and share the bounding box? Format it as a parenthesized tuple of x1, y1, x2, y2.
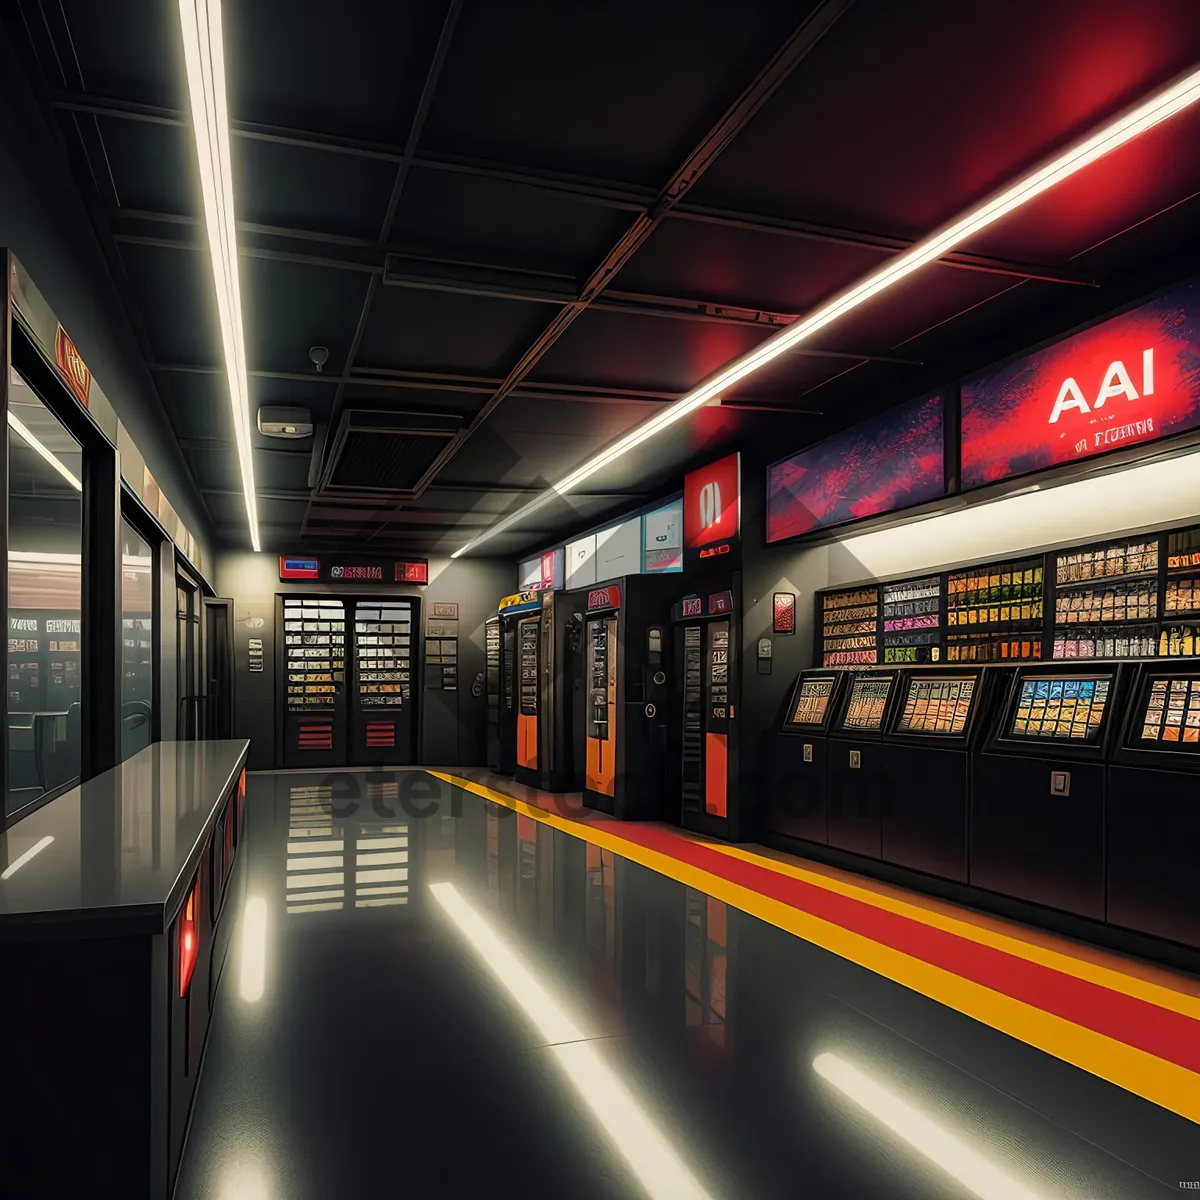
(828, 670, 900, 858)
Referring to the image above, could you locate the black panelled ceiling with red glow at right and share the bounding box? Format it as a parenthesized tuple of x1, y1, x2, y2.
(7, 0, 1200, 553)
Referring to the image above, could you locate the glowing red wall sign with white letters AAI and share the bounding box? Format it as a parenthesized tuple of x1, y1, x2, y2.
(962, 284, 1200, 488)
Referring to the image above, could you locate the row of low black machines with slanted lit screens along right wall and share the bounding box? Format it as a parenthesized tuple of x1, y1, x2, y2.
(768, 659, 1200, 948)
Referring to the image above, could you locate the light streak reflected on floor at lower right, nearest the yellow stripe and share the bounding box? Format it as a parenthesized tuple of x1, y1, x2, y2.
(812, 1054, 1038, 1200)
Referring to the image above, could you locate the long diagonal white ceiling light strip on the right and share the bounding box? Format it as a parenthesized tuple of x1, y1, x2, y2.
(450, 60, 1200, 558)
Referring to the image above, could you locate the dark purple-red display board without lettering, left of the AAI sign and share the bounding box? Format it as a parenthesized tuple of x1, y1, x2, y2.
(767, 396, 946, 542)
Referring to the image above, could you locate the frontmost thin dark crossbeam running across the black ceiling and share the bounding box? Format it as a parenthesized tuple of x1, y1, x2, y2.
(68, 91, 1097, 287)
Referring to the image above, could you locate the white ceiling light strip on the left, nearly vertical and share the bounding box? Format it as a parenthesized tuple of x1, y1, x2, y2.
(179, 0, 260, 551)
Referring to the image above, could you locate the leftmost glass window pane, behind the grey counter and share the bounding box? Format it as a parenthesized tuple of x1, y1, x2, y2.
(5, 372, 83, 812)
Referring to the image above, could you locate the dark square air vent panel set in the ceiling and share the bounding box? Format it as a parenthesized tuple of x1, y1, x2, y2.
(319, 408, 463, 502)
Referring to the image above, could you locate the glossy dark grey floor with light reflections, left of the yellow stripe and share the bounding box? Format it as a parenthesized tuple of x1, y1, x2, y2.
(176, 773, 1200, 1200)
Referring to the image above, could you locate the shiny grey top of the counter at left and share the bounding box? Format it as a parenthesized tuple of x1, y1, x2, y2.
(0, 740, 250, 938)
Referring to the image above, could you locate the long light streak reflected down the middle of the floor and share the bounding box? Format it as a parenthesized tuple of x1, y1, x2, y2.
(430, 883, 709, 1200)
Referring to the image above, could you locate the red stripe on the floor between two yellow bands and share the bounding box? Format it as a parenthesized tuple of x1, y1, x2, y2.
(568, 818, 1200, 1073)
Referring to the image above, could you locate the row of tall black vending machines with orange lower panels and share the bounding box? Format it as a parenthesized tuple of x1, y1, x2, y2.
(486, 575, 740, 838)
